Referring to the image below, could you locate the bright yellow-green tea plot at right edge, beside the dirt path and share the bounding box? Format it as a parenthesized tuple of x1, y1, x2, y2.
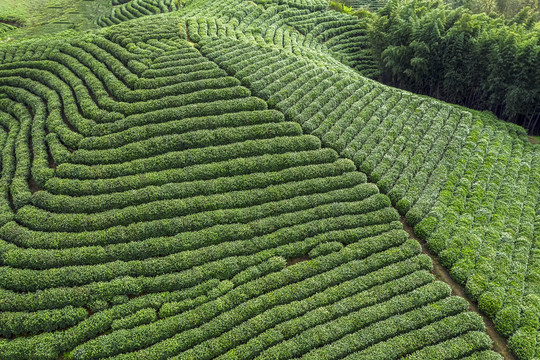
(417, 131, 540, 358)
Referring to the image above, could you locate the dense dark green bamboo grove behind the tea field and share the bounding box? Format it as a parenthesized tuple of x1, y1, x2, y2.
(360, 0, 540, 134)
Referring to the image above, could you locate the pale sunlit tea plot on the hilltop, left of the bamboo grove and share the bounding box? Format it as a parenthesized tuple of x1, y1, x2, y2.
(130, 0, 378, 77)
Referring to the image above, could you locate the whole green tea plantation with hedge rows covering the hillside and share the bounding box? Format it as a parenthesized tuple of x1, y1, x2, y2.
(0, 0, 540, 360)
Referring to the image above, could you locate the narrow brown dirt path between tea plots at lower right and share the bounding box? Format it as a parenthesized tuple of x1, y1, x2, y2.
(400, 216, 517, 360)
